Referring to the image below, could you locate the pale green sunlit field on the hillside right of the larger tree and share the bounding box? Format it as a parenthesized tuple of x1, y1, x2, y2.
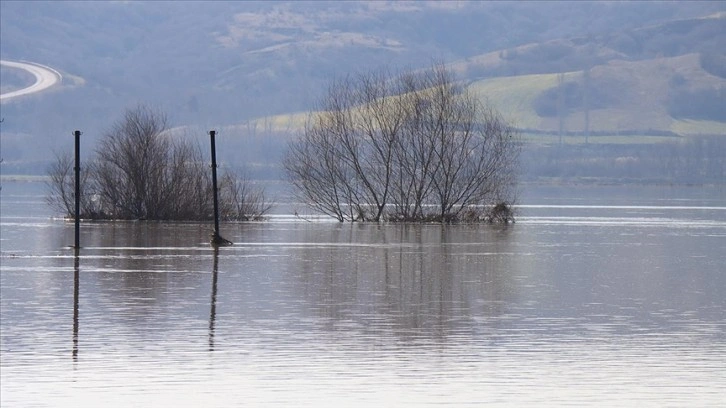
(470, 54, 726, 136)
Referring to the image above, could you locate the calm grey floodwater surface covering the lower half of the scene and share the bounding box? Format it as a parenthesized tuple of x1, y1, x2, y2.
(0, 182, 726, 407)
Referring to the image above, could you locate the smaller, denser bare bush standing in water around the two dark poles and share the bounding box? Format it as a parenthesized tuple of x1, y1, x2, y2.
(48, 106, 270, 221)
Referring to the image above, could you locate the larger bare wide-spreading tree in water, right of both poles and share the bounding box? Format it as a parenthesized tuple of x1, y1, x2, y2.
(283, 64, 520, 222)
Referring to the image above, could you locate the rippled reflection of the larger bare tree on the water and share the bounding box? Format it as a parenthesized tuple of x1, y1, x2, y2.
(296, 224, 516, 339)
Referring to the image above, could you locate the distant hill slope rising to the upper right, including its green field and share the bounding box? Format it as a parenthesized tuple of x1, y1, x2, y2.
(452, 13, 726, 135)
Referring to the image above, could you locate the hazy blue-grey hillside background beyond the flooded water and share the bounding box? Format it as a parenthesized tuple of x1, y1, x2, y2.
(0, 1, 726, 183)
